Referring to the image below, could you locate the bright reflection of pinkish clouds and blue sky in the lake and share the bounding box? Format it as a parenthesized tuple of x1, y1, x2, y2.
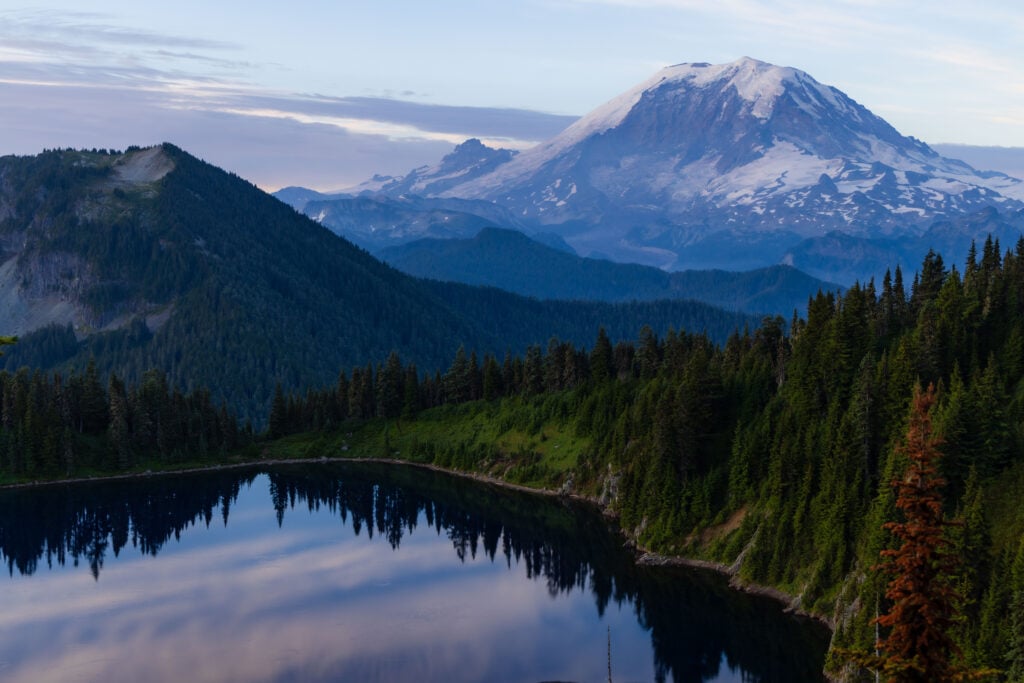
(0, 473, 653, 683)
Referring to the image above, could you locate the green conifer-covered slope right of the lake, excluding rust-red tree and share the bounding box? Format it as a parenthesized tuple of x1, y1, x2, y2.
(271, 240, 1024, 680)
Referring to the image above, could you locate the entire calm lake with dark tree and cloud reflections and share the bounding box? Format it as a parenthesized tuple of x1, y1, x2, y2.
(0, 464, 827, 683)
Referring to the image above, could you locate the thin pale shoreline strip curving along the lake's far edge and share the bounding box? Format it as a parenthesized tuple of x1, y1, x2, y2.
(0, 456, 836, 632)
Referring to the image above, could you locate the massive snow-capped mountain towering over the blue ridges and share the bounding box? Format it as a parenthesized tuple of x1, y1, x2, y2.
(362, 58, 1024, 268)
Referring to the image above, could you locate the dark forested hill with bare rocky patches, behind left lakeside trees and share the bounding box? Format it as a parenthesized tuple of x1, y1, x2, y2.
(0, 144, 756, 423)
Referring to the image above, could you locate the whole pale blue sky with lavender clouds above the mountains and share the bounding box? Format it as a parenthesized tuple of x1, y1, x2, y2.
(0, 0, 1024, 190)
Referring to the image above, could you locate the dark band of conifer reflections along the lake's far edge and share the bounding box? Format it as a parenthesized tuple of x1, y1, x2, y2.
(0, 463, 827, 681)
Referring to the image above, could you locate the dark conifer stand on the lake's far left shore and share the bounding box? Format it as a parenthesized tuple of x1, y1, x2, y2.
(0, 361, 247, 480)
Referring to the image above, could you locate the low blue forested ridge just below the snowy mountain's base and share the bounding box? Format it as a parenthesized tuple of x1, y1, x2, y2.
(380, 228, 842, 316)
